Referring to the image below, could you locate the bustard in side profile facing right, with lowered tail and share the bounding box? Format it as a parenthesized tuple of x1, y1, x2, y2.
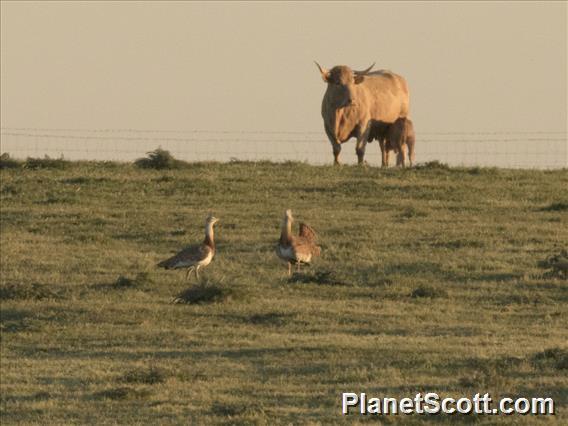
(158, 215, 219, 279)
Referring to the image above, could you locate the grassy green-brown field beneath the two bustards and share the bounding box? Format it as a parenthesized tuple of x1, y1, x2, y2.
(0, 158, 568, 424)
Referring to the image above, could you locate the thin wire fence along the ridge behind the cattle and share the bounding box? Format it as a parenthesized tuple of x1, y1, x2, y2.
(0, 127, 568, 169)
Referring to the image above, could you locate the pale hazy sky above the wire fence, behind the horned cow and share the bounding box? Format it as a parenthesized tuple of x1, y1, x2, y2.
(1, 1, 567, 132)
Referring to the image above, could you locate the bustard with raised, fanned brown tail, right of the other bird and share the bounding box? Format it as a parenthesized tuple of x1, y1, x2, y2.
(276, 210, 321, 276)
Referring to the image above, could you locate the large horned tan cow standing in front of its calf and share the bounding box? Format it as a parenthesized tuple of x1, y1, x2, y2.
(316, 62, 409, 164)
